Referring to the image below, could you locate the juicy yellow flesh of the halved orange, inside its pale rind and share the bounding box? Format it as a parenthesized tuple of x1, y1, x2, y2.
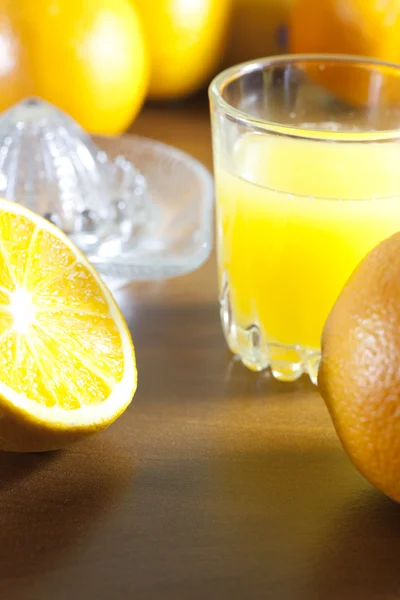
(0, 211, 124, 409)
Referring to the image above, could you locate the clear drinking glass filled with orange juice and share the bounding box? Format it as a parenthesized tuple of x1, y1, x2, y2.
(210, 55, 400, 383)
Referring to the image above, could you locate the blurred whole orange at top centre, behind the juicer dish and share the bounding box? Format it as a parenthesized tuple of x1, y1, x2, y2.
(132, 0, 231, 99)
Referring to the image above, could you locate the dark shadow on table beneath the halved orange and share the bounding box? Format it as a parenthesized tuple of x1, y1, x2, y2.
(0, 434, 134, 584)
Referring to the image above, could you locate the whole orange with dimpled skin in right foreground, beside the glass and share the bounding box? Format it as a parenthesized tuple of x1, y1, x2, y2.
(318, 233, 400, 502)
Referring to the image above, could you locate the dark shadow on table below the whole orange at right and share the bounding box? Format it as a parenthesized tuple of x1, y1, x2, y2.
(313, 489, 400, 600)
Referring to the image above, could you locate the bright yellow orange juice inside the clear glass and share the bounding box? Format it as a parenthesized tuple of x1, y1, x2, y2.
(215, 133, 400, 350)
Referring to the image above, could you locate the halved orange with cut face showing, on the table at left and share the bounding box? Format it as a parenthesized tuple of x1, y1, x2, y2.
(0, 199, 137, 452)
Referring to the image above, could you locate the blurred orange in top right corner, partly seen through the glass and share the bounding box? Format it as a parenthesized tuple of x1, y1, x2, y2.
(289, 0, 400, 105)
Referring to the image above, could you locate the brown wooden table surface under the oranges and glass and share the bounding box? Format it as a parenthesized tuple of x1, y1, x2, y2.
(0, 103, 400, 600)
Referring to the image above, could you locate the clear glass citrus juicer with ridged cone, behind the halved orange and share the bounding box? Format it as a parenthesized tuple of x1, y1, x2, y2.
(0, 98, 213, 288)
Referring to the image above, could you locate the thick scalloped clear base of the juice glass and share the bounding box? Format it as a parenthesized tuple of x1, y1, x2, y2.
(220, 285, 321, 385)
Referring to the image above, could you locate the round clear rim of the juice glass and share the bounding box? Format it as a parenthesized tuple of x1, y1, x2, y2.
(208, 53, 400, 142)
